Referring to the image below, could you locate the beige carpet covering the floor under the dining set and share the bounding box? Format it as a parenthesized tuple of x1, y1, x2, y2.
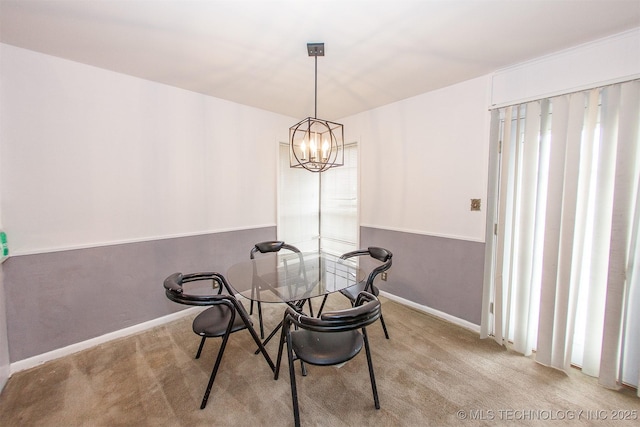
(0, 295, 640, 426)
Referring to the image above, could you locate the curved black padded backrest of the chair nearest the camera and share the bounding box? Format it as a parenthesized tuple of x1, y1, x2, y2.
(284, 291, 380, 332)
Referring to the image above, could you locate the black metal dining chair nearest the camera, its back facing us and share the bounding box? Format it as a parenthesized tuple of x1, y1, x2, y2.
(274, 292, 380, 427)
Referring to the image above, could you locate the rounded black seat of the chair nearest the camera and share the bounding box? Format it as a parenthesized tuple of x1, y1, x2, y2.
(291, 329, 363, 366)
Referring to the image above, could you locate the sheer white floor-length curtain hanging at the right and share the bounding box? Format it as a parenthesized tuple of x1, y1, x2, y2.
(481, 80, 640, 394)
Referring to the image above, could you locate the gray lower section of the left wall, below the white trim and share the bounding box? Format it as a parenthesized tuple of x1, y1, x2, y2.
(3, 227, 276, 362)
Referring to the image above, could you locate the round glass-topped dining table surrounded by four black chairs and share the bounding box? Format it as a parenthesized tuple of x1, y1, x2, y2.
(226, 252, 366, 344)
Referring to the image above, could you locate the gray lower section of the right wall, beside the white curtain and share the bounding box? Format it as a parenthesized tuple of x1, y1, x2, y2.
(360, 227, 484, 325)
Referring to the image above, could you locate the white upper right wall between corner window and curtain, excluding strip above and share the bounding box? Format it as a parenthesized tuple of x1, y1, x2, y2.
(343, 76, 490, 241)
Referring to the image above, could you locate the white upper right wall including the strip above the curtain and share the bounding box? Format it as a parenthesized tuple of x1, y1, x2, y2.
(342, 29, 640, 241)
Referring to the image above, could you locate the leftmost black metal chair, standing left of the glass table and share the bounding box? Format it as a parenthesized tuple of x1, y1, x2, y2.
(164, 273, 275, 409)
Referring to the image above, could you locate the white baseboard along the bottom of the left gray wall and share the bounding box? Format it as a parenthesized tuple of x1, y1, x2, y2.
(9, 307, 203, 376)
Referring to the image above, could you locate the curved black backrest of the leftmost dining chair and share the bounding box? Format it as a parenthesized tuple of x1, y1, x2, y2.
(164, 272, 235, 305)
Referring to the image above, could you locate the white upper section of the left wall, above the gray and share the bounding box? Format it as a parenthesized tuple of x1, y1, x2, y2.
(0, 45, 293, 255)
